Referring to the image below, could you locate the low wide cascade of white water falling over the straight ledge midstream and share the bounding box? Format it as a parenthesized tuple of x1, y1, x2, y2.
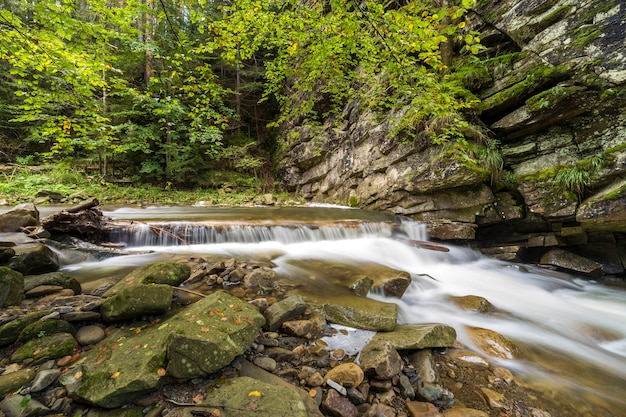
(109, 220, 426, 247)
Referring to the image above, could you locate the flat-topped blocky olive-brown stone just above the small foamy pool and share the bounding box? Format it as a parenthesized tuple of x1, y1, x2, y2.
(323, 297, 398, 332)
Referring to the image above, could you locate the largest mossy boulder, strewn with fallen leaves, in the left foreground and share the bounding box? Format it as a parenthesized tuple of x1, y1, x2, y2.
(68, 291, 265, 408)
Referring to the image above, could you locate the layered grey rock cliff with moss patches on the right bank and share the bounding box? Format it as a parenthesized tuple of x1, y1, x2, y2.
(281, 0, 626, 275)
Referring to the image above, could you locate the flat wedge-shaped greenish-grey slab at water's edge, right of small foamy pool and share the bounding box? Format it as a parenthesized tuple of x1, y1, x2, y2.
(373, 323, 456, 350)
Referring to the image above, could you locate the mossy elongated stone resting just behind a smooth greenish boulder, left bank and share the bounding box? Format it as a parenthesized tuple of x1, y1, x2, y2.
(102, 262, 191, 298)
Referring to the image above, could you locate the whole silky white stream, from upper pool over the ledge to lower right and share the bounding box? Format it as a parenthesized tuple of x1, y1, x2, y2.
(50, 207, 626, 417)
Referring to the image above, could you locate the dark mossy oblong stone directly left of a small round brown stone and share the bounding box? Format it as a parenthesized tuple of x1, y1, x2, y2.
(11, 333, 76, 365)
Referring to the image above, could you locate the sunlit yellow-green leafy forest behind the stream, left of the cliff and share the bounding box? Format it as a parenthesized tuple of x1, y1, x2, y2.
(0, 0, 482, 188)
